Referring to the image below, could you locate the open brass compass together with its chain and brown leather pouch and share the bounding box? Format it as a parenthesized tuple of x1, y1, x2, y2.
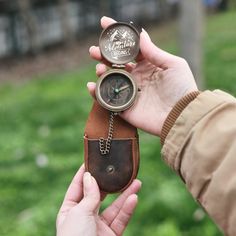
(84, 22, 139, 193)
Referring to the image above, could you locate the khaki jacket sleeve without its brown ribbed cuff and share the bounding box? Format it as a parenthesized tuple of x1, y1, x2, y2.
(162, 90, 236, 236)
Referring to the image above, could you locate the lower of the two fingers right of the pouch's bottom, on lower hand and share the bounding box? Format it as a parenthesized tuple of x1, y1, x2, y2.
(110, 194, 138, 235)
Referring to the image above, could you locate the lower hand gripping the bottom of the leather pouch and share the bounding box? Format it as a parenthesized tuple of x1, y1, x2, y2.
(56, 166, 141, 236)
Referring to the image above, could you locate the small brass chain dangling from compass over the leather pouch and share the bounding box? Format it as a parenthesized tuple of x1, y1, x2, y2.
(99, 112, 116, 155)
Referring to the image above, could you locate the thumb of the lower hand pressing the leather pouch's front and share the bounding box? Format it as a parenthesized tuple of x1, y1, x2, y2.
(78, 172, 100, 213)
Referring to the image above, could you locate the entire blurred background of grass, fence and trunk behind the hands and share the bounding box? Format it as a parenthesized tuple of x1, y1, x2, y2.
(0, 0, 236, 236)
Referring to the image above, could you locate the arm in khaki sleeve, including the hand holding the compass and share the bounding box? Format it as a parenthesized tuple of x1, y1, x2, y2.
(88, 17, 236, 235)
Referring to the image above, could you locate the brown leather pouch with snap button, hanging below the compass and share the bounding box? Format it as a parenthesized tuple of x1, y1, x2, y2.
(84, 102, 139, 193)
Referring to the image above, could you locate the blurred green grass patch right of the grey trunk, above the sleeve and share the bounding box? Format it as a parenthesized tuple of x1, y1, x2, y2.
(205, 11, 236, 95)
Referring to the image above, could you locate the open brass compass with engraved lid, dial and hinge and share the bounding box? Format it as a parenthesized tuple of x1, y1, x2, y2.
(95, 22, 139, 113)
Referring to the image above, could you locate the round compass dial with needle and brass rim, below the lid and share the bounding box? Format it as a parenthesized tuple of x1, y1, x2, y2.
(96, 70, 137, 112)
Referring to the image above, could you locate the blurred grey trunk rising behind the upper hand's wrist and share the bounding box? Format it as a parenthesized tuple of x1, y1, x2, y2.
(180, 0, 205, 89)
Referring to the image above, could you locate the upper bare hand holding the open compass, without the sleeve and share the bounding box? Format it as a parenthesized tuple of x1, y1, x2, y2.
(88, 17, 198, 136)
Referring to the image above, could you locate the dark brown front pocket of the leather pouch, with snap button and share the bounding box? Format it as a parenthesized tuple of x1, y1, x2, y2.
(84, 137, 139, 193)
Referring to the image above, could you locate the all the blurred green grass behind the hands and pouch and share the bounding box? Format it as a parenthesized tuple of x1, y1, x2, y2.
(0, 12, 236, 236)
